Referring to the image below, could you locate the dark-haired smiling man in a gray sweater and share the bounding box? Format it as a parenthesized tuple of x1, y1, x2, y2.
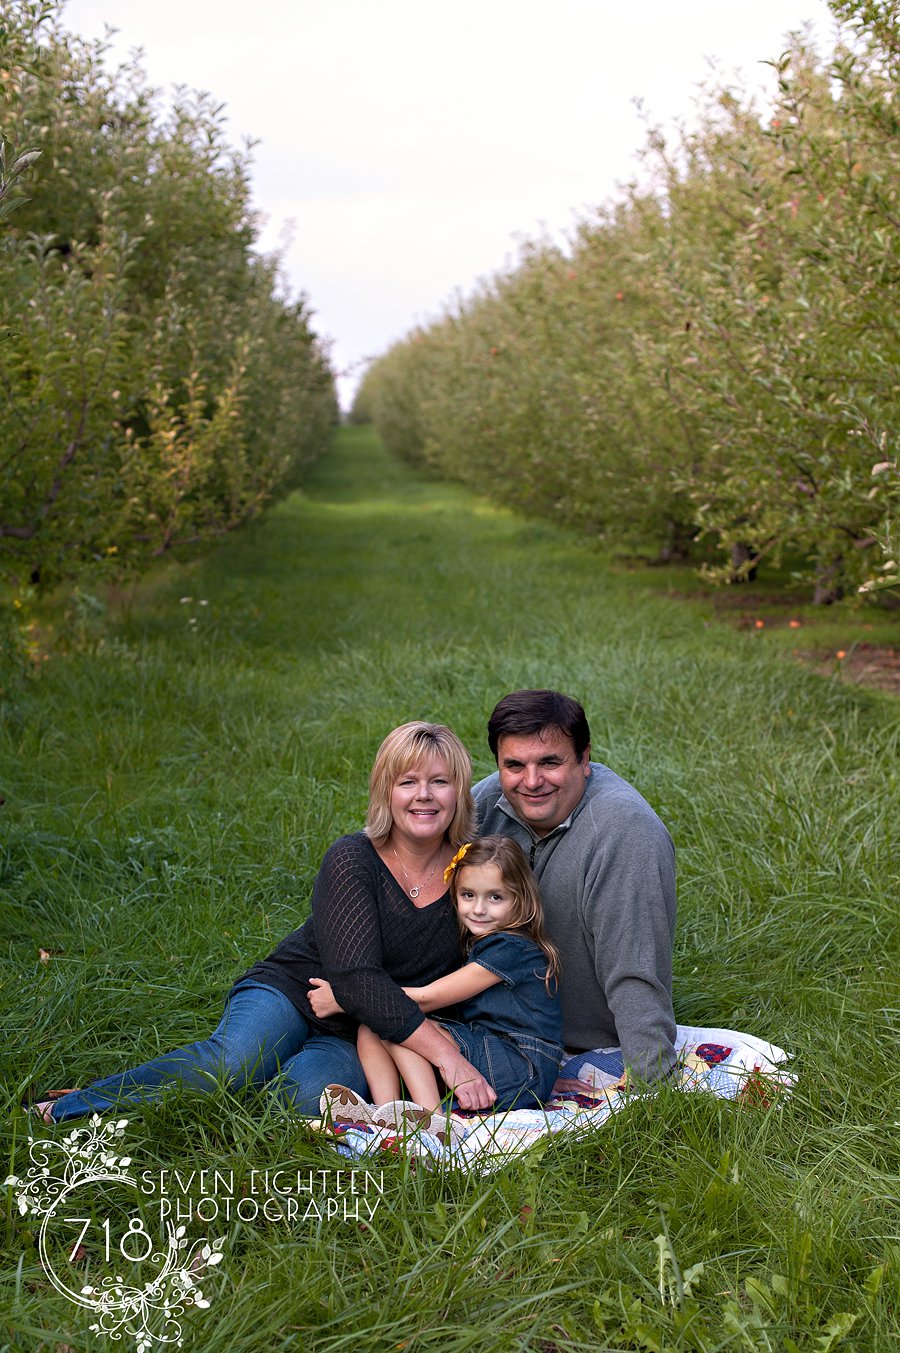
(474, 690, 675, 1081)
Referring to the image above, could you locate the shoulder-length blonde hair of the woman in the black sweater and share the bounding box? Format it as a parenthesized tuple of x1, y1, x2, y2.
(365, 720, 475, 847)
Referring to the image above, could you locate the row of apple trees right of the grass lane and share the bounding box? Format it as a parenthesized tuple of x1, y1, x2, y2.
(355, 0, 900, 601)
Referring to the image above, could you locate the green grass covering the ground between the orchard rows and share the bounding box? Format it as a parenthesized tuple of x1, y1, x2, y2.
(0, 429, 900, 1353)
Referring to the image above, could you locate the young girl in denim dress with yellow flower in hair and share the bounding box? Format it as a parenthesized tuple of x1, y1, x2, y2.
(357, 836, 563, 1109)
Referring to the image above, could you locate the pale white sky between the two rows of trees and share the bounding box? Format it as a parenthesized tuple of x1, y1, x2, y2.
(64, 0, 832, 405)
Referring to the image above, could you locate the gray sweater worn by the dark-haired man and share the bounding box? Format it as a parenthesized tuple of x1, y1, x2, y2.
(474, 762, 675, 1081)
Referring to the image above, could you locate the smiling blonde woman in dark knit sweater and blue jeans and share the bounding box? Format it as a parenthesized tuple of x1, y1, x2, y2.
(37, 723, 494, 1123)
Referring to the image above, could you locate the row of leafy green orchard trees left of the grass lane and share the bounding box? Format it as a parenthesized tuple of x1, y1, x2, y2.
(0, 0, 336, 586)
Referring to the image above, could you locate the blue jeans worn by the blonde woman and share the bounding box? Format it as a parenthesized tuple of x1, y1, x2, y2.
(44, 982, 368, 1123)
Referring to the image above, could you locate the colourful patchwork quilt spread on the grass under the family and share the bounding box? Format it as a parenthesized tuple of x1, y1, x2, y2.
(311, 1024, 794, 1173)
